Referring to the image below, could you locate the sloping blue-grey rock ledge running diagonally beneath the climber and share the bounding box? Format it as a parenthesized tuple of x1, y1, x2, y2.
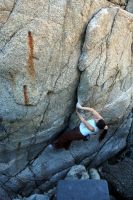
(1, 114, 132, 198)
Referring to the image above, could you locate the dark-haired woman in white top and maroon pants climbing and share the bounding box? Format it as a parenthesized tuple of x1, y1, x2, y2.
(50, 103, 108, 149)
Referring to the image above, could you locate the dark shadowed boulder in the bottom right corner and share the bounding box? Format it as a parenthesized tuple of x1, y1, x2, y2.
(101, 158, 133, 200)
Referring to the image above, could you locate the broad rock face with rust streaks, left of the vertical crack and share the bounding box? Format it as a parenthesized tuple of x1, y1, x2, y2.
(0, 0, 108, 173)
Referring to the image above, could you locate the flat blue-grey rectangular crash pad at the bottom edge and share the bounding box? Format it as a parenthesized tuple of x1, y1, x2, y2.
(57, 180, 110, 200)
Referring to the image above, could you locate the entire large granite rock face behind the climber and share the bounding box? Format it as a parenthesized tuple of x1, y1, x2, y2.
(0, 0, 133, 198)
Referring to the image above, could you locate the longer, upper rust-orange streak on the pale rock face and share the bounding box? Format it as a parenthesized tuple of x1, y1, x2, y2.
(28, 31, 35, 78)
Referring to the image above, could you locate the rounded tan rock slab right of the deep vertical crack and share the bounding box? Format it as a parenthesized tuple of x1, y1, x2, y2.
(78, 8, 133, 123)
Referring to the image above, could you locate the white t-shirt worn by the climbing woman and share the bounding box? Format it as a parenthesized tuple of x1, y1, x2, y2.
(79, 119, 99, 136)
